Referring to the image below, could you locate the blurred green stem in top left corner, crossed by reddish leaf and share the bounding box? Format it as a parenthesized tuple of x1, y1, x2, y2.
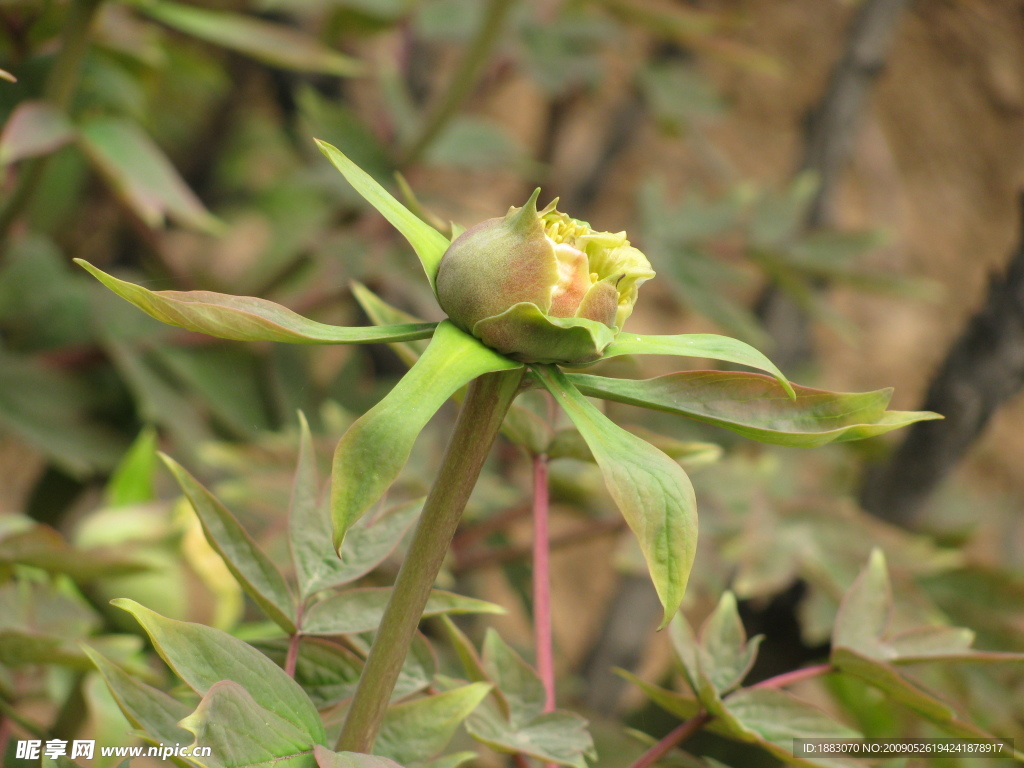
(0, 0, 102, 242)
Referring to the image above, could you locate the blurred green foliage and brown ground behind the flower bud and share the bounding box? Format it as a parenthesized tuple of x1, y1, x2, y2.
(0, 0, 1024, 765)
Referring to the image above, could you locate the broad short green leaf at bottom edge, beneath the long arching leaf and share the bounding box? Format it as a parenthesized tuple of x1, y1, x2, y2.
(181, 680, 316, 768)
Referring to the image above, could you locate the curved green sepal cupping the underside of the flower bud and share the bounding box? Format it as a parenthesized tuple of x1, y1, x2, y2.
(473, 302, 614, 366)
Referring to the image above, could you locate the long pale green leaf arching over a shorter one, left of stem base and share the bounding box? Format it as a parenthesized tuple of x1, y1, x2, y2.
(111, 598, 325, 743)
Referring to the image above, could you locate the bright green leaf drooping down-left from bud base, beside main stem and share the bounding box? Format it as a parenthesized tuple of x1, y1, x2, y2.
(331, 321, 522, 548)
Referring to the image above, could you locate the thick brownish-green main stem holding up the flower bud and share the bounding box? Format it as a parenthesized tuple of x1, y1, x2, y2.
(337, 369, 524, 753)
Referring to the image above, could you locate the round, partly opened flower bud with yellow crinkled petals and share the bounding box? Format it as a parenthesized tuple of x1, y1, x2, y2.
(436, 189, 654, 366)
